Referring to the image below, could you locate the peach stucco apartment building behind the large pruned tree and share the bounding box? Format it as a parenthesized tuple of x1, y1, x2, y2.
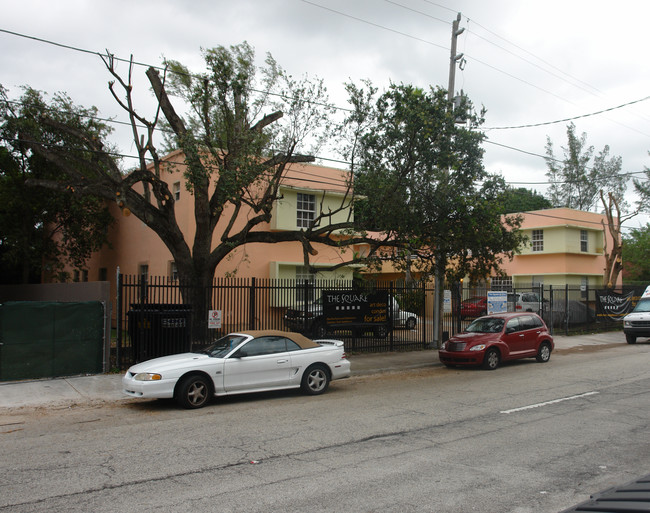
(68, 152, 359, 290)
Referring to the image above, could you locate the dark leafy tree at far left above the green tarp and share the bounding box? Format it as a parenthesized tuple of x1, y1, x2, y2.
(0, 87, 112, 283)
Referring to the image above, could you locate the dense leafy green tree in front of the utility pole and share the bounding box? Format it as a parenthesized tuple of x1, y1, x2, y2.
(347, 83, 523, 279)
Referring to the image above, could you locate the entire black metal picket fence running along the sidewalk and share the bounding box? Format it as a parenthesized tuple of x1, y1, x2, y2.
(115, 275, 640, 368)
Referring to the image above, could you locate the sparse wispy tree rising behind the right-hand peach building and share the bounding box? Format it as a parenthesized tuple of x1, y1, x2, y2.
(546, 123, 627, 211)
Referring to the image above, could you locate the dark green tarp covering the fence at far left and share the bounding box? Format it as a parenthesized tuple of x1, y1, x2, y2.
(0, 301, 104, 381)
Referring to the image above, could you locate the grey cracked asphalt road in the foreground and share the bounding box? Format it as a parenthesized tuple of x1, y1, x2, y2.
(0, 343, 650, 513)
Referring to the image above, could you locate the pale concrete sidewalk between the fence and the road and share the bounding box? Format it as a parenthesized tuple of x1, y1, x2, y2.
(0, 331, 626, 413)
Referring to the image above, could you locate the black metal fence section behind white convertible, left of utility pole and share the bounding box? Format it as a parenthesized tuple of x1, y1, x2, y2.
(116, 275, 440, 368)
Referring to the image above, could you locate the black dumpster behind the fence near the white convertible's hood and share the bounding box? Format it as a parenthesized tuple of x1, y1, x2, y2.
(127, 303, 192, 362)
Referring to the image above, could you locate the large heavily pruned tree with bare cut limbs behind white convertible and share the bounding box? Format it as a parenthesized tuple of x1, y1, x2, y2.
(12, 43, 395, 333)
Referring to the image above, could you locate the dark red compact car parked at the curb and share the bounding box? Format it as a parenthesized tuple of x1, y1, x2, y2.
(439, 312, 555, 370)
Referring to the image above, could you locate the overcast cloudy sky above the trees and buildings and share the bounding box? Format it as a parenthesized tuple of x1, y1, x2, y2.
(0, 0, 650, 227)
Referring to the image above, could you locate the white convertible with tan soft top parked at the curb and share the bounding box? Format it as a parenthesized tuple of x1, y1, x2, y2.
(122, 331, 350, 408)
